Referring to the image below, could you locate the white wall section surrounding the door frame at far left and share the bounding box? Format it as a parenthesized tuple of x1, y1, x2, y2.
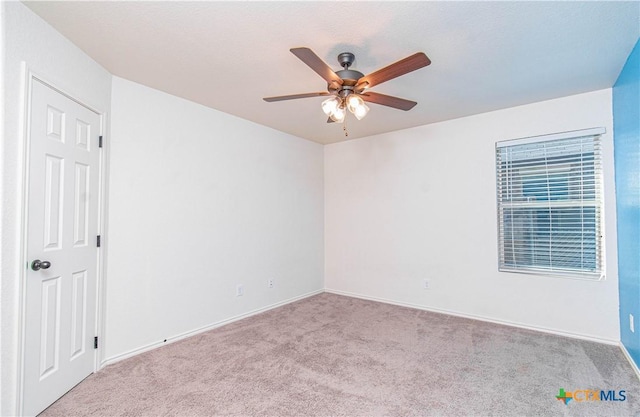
(0, 1, 111, 415)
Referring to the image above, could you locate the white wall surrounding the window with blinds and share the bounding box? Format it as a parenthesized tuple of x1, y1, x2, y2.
(325, 90, 619, 341)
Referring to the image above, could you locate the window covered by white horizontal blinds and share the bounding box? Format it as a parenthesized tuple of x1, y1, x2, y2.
(496, 128, 604, 279)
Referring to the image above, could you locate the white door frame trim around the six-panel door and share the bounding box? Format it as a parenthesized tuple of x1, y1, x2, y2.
(16, 65, 109, 415)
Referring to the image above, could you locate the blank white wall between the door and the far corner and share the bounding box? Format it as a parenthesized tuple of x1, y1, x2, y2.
(106, 77, 324, 361)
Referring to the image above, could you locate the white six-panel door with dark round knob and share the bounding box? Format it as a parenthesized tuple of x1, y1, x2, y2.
(23, 79, 100, 415)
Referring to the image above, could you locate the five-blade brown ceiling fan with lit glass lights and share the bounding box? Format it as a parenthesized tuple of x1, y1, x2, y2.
(263, 48, 431, 123)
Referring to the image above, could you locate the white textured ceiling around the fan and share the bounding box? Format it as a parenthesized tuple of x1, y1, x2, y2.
(26, 1, 640, 143)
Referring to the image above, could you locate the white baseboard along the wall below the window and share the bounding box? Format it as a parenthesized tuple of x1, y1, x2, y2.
(325, 288, 620, 346)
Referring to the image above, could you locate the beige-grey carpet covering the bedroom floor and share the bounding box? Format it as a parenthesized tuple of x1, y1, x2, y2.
(42, 294, 640, 416)
